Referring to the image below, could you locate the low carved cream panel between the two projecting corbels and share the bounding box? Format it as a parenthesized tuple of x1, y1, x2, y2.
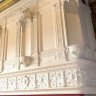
(40, 48, 66, 65)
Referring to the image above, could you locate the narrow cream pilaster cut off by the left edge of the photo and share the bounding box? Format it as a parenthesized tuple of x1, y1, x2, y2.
(0, 19, 8, 72)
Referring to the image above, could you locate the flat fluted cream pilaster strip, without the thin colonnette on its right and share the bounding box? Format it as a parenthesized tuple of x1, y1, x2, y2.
(54, 2, 64, 47)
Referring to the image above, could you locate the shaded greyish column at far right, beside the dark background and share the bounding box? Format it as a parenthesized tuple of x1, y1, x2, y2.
(79, 1, 96, 50)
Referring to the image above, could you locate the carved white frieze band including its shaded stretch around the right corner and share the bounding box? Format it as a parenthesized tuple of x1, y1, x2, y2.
(0, 64, 96, 92)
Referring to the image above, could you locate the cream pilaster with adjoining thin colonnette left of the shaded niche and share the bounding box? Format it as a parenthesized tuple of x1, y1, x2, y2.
(54, 0, 68, 60)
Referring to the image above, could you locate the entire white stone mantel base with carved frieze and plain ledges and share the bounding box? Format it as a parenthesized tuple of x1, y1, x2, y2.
(0, 59, 96, 95)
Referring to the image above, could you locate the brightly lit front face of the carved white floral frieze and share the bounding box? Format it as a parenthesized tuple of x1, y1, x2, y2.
(0, 69, 81, 91)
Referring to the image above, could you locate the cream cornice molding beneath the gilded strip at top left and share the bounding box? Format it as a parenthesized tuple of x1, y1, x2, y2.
(0, 0, 37, 19)
